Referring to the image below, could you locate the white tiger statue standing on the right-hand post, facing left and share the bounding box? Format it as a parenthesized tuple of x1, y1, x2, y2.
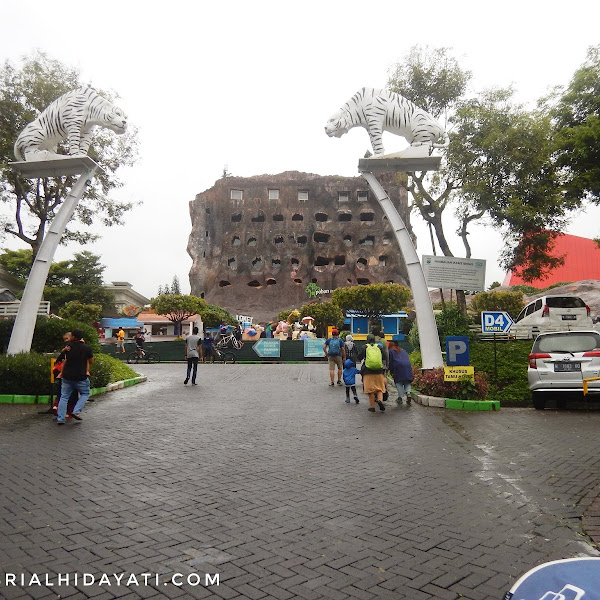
(325, 87, 449, 155)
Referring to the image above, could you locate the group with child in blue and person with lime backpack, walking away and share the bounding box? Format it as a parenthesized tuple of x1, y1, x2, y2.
(323, 329, 413, 412)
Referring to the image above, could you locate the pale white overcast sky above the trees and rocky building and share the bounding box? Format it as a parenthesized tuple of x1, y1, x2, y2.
(0, 0, 600, 297)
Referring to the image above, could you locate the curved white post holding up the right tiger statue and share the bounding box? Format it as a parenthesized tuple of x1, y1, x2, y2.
(361, 171, 444, 369)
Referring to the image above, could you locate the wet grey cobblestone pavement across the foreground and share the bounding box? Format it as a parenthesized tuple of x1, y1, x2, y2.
(0, 364, 600, 600)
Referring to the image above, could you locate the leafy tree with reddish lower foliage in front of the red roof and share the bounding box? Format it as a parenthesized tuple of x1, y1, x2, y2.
(447, 89, 577, 281)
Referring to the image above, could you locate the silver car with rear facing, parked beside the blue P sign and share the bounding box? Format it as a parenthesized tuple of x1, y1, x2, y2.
(527, 330, 600, 410)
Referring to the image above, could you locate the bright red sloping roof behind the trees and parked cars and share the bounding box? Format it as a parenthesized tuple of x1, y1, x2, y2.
(502, 234, 600, 288)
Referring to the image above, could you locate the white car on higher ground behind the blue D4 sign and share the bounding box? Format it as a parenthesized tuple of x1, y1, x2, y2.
(511, 296, 593, 339)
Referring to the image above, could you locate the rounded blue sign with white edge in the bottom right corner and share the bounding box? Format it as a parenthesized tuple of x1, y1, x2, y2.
(504, 557, 600, 600)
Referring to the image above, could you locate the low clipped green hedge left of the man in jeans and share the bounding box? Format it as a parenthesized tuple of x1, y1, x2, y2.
(0, 352, 52, 396)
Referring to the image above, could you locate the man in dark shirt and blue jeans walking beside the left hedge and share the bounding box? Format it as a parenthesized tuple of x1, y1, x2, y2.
(56, 329, 94, 425)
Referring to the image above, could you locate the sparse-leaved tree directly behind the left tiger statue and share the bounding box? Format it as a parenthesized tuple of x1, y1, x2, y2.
(0, 52, 137, 256)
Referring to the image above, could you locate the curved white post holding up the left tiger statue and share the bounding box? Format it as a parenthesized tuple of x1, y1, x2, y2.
(7, 165, 98, 354)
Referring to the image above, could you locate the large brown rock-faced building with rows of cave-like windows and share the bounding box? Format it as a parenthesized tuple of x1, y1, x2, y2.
(188, 171, 409, 321)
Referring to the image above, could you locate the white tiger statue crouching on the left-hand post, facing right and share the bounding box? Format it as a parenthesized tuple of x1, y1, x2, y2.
(15, 88, 127, 161)
